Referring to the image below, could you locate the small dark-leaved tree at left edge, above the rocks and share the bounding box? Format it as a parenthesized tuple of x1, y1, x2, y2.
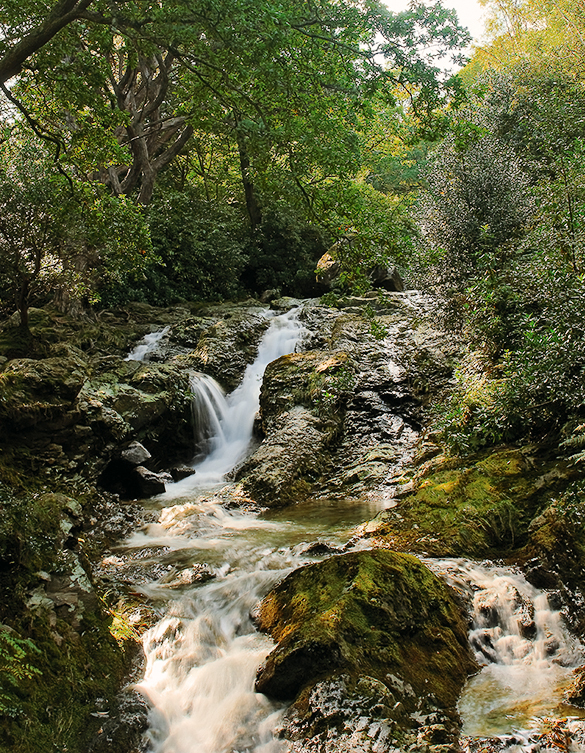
(0, 134, 150, 332)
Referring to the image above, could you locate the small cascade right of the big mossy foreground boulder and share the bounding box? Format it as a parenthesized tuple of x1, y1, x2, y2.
(428, 560, 584, 740)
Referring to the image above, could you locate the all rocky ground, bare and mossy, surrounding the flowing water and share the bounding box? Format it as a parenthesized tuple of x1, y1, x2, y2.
(0, 292, 585, 753)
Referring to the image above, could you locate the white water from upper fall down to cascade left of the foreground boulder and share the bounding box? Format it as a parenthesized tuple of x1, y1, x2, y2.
(127, 312, 320, 753)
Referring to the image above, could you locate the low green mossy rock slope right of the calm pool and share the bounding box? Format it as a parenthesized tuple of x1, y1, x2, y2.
(365, 448, 571, 557)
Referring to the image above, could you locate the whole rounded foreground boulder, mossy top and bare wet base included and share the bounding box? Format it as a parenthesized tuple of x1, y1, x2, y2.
(256, 549, 477, 753)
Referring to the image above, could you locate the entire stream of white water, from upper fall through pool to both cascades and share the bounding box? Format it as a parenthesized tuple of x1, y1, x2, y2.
(116, 310, 584, 753)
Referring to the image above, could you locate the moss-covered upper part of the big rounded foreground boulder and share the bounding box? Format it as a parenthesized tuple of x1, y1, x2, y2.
(256, 549, 476, 707)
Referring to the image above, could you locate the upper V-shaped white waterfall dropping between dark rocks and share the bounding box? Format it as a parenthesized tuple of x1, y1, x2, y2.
(165, 309, 306, 499)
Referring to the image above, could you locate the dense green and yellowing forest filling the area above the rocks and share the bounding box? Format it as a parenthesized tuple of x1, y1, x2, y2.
(0, 0, 585, 750)
